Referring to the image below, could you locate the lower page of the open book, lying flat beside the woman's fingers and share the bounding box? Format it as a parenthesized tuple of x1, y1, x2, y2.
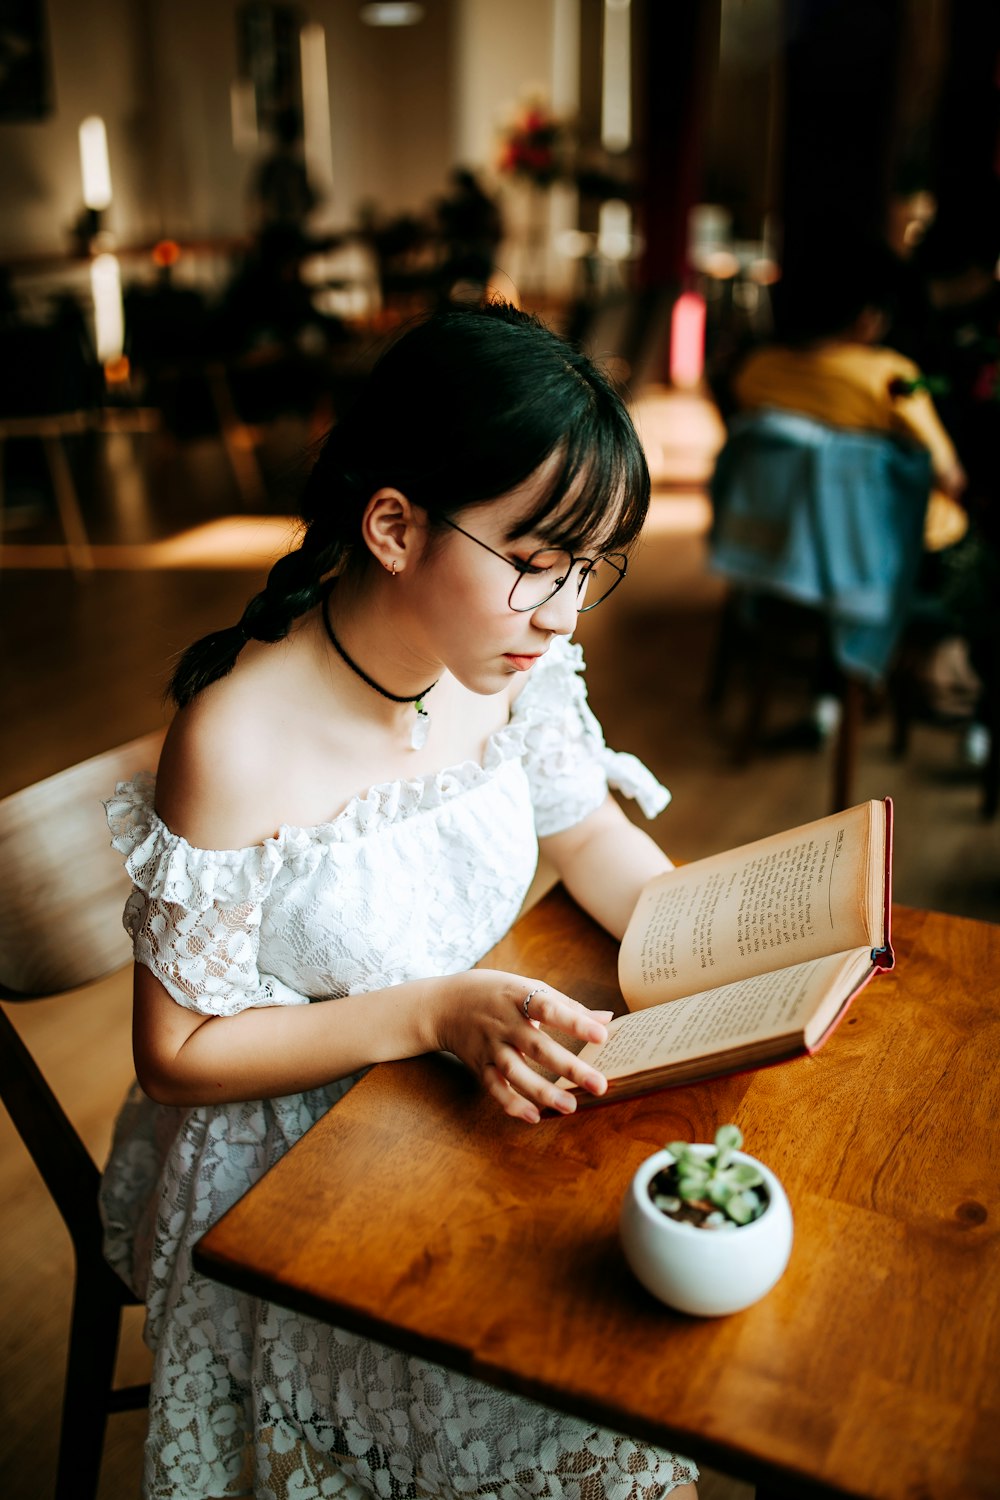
(569, 948, 871, 1082)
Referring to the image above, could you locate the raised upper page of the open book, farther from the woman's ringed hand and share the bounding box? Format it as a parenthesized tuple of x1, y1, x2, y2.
(618, 801, 885, 1011)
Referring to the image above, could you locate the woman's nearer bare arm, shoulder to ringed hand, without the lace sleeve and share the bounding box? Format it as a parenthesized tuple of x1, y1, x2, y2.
(133, 672, 610, 1122)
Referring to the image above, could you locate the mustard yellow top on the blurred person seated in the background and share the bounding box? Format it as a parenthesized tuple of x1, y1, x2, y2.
(733, 341, 969, 552)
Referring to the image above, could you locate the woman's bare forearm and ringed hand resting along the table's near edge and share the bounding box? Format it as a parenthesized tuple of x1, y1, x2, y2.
(132, 965, 610, 1124)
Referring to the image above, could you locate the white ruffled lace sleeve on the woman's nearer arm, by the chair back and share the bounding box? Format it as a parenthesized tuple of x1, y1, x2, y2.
(105, 776, 309, 1016)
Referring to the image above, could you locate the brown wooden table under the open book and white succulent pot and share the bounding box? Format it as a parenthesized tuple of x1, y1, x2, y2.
(195, 890, 1000, 1500)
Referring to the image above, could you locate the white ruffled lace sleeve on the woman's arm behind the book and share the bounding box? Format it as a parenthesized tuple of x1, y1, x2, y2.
(514, 641, 670, 839)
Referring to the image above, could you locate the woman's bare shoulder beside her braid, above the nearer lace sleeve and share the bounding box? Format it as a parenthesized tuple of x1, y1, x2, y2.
(156, 651, 290, 849)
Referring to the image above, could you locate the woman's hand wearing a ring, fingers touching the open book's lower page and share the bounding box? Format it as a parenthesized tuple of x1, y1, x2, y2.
(435, 969, 615, 1125)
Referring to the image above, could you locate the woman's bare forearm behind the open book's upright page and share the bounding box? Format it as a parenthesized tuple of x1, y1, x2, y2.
(540, 794, 673, 939)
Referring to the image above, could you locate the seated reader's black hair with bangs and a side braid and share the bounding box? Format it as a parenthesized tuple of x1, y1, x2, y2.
(169, 302, 649, 707)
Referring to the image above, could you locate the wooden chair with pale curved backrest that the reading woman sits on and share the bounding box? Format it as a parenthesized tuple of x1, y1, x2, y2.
(0, 732, 162, 1500)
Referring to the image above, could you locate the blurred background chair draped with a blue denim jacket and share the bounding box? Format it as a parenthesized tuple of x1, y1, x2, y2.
(709, 410, 931, 809)
